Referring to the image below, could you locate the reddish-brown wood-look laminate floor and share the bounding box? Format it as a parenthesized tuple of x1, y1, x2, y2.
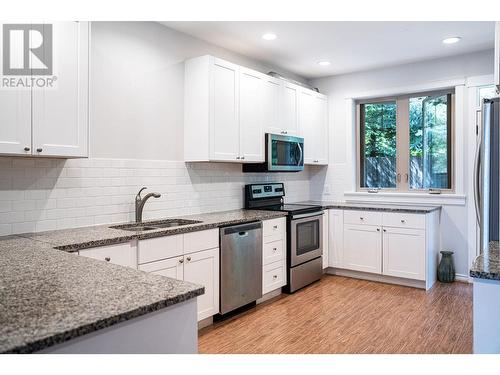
(199, 275, 472, 354)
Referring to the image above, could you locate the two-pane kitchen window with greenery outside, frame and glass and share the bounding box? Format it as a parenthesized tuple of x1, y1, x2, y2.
(356, 90, 455, 192)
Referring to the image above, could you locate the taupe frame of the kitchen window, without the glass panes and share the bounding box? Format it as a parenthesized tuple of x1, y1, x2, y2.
(354, 88, 456, 194)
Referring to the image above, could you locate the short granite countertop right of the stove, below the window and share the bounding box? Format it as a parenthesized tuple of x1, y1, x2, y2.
(297, 200, 441, 214)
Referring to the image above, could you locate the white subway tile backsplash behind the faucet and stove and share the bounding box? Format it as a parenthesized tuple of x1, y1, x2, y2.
(0, 157, 310, 235)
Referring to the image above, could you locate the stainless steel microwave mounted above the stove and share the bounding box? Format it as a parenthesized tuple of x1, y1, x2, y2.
(243, 133, 304, 172)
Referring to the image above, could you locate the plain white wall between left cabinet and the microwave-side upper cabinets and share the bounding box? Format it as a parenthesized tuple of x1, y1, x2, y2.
(90, 22, 305, 160)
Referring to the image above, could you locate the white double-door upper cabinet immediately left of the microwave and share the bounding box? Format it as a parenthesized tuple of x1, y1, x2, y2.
(184, 56, 264, 163)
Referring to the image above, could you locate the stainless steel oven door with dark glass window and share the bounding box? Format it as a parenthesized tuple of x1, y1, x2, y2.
(290, 211, 323, 267)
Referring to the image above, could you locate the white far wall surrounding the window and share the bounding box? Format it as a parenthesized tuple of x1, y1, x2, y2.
(311, 51, 493, 275)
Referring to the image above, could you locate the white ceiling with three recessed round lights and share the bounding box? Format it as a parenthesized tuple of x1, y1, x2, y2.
(162, 21, 494, 78)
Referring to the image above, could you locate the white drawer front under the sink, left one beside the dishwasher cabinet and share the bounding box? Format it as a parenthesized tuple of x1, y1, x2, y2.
(138, 234, 183, 264)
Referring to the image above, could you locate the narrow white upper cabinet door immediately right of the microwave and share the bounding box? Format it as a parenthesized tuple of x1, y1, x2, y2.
(299, 89, 317, 164)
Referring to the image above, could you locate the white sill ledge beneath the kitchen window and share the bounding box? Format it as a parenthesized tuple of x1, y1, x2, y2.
(344, 191, 467, 206)
